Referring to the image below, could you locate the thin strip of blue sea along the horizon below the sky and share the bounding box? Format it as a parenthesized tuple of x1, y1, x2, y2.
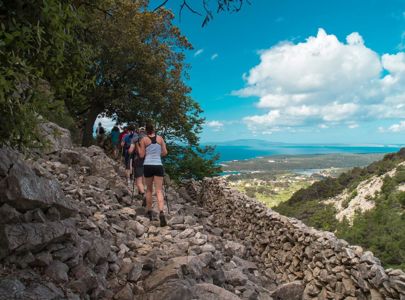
(211, 145, 401, 162)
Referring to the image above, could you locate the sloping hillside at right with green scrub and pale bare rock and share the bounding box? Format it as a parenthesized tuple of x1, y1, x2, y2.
(275, 149, 405, 270)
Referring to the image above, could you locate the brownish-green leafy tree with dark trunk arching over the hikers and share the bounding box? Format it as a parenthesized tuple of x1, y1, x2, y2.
(76, 0, 203, 145)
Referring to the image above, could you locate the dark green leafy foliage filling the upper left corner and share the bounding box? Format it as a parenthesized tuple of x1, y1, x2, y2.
(0, 0, 90, 148)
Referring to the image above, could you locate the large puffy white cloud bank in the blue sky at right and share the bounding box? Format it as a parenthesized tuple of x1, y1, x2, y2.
(233, 29, 405, 131)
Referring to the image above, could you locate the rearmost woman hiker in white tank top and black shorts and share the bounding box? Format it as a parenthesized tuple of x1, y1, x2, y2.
(138, 124, 167, 227)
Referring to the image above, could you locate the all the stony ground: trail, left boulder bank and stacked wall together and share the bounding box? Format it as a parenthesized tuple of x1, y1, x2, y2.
(0, 123, 405, 300)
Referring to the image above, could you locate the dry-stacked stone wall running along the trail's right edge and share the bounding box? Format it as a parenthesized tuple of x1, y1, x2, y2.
(186, 178, 405, 299)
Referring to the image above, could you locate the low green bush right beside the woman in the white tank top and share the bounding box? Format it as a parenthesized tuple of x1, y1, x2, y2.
(164, 144, 222, 181)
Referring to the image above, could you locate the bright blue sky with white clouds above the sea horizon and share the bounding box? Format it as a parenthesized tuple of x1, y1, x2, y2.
(152, 0, 405, 144)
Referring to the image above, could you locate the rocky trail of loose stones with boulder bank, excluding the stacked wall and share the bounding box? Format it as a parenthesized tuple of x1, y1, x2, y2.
(0, 129, 284, 300)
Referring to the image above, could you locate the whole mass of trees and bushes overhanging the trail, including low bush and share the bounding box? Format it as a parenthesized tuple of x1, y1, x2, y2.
(0, 0, 218, 178)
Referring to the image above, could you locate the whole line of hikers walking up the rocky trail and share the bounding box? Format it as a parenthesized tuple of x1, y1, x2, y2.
(96, 123, 167, 227)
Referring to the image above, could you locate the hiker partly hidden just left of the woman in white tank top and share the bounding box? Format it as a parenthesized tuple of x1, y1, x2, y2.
(128, 127, 146, 207)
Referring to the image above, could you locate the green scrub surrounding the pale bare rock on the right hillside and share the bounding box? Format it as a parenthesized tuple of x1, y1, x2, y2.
(274, 148, 405, 269)
